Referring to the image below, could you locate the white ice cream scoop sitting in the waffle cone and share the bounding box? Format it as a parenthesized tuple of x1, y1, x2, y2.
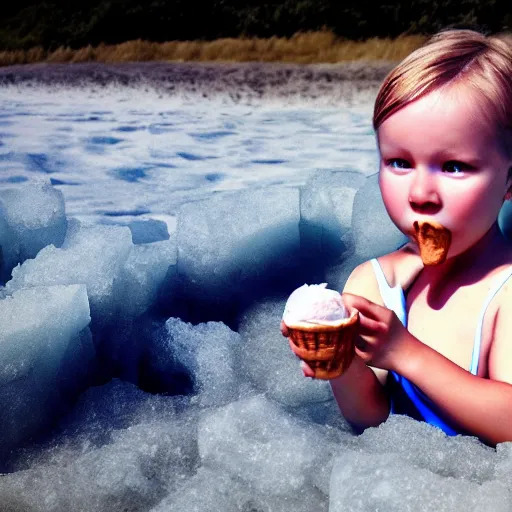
(283, 283, 348, 327)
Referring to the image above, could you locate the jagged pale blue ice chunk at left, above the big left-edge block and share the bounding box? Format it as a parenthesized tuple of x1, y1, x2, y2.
(6, 221, 133, 324)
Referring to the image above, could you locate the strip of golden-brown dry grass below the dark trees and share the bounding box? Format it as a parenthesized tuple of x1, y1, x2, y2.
(0, 31, 432, 66)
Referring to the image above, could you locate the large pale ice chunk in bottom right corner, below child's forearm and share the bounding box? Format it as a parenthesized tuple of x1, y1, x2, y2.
(329, 415, 511, 512)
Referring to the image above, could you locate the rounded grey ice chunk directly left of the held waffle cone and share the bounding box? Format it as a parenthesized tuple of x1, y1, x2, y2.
(238, 300, 332, 406)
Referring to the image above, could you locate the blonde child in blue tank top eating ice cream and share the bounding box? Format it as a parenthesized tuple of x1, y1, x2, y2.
(282, 30, 512, 445)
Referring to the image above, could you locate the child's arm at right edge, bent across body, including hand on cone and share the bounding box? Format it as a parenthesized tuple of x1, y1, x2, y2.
(346, 290, 512, 445)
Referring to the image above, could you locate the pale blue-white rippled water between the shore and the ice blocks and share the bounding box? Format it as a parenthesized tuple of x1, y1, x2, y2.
(0, 72, 376, 232)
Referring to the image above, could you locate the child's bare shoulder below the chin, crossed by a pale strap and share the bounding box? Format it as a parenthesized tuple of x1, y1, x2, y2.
(343, 243, 423, 305)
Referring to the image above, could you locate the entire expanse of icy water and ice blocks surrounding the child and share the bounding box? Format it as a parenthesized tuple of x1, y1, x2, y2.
(0, 66, 512, 512)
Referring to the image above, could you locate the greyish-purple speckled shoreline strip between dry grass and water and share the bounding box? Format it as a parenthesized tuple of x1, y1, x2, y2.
(0, 61, 395, 102)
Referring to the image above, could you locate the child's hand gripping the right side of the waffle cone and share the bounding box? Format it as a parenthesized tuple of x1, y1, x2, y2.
(342, 293, 411, 371)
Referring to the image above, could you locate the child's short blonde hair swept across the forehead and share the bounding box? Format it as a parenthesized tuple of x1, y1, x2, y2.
(373, 29, 512, 157)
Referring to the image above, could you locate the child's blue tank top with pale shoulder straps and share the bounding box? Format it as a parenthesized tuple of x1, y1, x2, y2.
(370, 258, 512, 436)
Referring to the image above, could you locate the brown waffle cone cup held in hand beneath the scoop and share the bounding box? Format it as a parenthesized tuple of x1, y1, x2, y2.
(288, 310, 359, 380)
